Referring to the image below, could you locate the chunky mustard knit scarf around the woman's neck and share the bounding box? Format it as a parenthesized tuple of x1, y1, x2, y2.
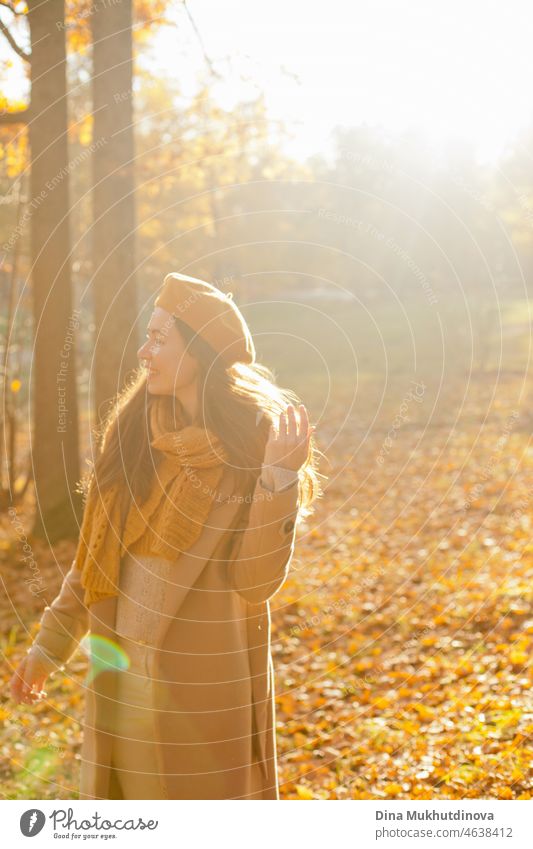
(75, 396, 228, 606)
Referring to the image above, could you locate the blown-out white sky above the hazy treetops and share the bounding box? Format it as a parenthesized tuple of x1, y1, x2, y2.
(145, 0, 533, 166)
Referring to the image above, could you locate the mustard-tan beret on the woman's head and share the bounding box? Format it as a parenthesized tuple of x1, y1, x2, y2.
(154, 271, 255, 364)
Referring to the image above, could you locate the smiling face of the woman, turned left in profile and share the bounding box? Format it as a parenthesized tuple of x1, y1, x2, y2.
(137, 307, 197, 397)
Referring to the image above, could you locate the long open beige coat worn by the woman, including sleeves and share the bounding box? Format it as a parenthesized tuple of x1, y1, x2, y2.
(34, 469, 299, 799)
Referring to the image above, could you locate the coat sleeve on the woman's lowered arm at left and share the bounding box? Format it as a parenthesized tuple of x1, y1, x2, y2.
(30, 561, 89, 666)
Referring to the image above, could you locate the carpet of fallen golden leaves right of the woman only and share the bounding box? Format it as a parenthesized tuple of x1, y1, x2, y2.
(272, 388, 533, 799)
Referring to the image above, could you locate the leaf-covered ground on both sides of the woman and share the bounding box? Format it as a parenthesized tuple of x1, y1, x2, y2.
(0, 374, 533, 799)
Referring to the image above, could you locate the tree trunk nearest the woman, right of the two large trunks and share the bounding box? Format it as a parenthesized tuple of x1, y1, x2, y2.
(91, 0, 139, 424)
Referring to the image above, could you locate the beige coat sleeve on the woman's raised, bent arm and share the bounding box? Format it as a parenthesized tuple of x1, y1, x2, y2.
(224, 476, 299, 604)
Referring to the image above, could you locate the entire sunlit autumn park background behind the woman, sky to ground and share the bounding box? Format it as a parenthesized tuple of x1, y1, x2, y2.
(0, 0, 533, 799)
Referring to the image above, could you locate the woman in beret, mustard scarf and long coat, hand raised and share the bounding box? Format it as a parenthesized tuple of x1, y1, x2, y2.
(11, 274, 321, 799)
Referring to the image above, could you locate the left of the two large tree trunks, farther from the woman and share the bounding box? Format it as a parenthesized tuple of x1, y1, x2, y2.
(28, 0, 82, 542)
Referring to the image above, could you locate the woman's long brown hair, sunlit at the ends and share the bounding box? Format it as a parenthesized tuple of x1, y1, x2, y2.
(78, 317, 324, 517)
